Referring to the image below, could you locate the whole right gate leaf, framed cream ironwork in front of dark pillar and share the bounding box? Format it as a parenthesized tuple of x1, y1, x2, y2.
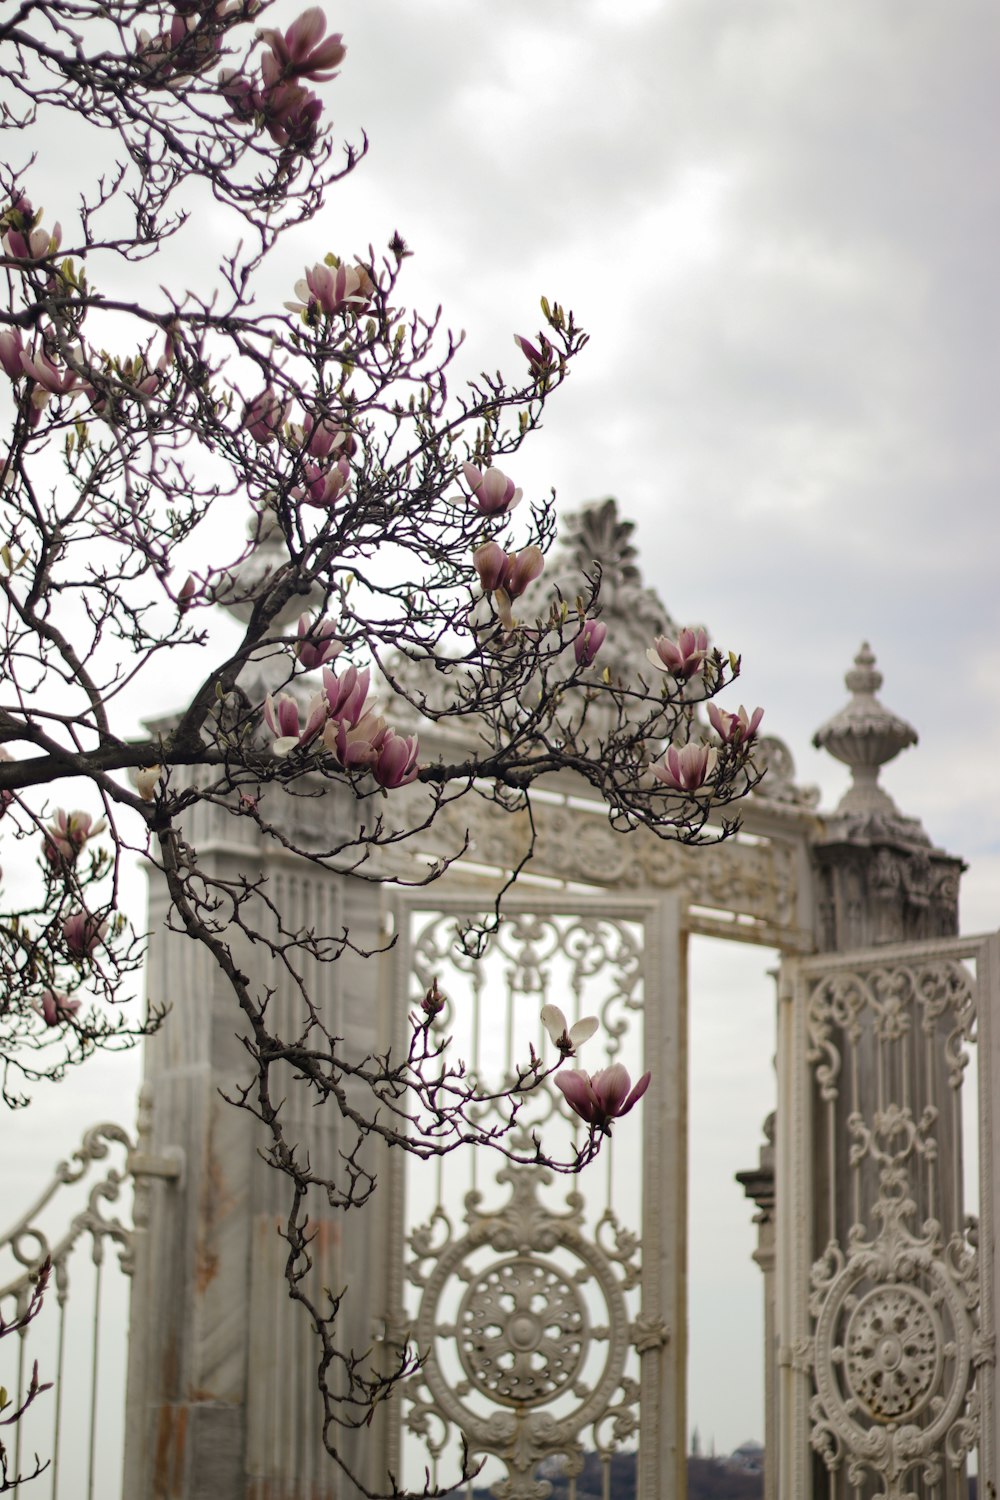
(777, 939, 999, 1500)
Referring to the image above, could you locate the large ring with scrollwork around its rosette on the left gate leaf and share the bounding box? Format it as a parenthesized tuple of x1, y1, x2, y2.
(406, 1167, 641, 1500)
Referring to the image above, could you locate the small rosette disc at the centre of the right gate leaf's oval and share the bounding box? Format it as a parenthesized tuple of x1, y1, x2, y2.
(846, 1283, 942, 1422)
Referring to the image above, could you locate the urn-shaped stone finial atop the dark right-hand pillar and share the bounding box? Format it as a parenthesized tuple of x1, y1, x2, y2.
(813, 641, 916, 816)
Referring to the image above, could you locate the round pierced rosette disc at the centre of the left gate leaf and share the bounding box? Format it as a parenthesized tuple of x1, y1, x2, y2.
(456, 1256, 588, 1406)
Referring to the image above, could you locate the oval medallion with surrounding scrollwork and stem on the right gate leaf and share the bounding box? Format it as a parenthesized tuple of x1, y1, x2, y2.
(810, 1106, 984, 1500)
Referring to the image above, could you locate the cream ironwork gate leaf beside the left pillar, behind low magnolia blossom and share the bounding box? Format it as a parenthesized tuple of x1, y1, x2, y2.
(390, 893, 679, 1500)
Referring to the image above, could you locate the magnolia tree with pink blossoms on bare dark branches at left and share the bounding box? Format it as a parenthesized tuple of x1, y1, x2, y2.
(0, 0, 760, 1488)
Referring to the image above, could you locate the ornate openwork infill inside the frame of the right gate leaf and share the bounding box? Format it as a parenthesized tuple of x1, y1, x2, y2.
(804, 953, 991, 1500)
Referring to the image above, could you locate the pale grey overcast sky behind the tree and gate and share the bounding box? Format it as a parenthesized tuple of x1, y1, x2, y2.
(1, 0, 1000, 1476)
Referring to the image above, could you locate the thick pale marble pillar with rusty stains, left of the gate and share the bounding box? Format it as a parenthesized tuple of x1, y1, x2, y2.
(124, 788, 384, 1500)
